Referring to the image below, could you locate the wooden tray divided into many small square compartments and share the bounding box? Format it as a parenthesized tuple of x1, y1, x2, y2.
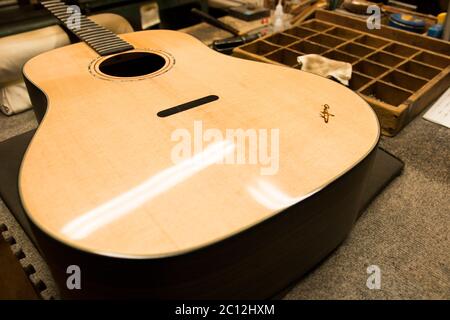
(233, 10, 450, 136)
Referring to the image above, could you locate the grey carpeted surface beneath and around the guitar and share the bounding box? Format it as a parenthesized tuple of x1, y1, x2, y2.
(0, 112, 450, 299)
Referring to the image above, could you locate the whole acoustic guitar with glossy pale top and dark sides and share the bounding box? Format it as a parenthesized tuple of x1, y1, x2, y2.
(19, 0, 380, 298)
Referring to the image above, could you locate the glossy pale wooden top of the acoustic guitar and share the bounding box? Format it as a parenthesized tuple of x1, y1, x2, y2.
(19, 31, 379, 258)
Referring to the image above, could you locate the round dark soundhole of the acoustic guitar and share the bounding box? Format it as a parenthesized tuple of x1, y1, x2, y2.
(98, 52, 166, 78)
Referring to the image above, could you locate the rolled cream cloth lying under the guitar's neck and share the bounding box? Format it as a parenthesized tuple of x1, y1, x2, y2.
(0, 13, 133, 115)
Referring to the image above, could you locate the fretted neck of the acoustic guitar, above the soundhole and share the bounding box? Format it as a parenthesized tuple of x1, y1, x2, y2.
(41, 0, 134, 56)
